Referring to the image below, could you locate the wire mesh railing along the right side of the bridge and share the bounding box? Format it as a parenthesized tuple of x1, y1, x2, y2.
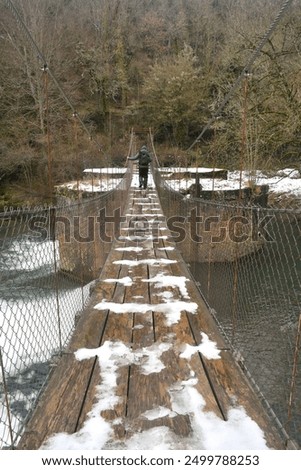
(153, 166, 301, 446)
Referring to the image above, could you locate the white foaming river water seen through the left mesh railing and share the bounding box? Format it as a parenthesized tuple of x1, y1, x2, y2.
(0, 235, 89, 445)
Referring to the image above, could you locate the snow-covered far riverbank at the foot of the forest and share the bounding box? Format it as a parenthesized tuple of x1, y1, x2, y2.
(0, 167, 301, 212)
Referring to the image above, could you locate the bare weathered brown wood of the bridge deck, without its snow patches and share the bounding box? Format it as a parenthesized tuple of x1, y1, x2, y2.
(19, 182, 284, 449)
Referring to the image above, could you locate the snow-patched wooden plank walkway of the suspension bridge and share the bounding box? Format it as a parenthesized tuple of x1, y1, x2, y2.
(19, 174, 284, 449)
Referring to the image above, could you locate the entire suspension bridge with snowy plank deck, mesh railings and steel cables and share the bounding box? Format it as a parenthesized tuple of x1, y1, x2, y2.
(0, 1, 301, 449)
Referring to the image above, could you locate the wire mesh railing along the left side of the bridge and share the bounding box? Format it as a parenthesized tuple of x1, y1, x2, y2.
(0, 165, 131, 448)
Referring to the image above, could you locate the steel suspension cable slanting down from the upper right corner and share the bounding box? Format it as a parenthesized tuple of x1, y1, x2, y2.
(188, 0, 293, 150)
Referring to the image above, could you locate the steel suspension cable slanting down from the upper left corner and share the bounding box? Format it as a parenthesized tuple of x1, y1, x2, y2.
(5, 0, 103, 152)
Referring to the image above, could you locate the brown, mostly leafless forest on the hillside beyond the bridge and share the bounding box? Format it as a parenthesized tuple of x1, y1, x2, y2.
(0, 0, 301, 202)
